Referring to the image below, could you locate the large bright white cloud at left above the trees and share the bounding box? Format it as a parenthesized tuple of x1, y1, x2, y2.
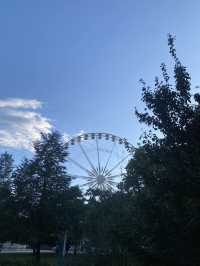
(0, 99, 52, 150)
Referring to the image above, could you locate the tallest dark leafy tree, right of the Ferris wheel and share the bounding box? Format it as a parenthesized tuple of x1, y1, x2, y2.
(124, 35, 200, 265)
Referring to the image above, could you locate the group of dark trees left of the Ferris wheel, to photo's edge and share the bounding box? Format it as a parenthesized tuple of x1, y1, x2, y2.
(0, 132, 84, 256)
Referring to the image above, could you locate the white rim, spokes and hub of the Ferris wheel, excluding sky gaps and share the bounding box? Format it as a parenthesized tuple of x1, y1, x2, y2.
(66, 132, 135, 190)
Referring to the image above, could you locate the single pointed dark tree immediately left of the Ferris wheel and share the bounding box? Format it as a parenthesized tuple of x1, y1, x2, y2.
(14, 132, 81, 255)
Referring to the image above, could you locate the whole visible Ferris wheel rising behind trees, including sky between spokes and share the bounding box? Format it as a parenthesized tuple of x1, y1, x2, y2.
(67, 133, 134, 191)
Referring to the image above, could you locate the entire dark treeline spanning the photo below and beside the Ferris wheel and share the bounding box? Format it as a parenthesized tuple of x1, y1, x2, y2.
(0, 36, 200, 266)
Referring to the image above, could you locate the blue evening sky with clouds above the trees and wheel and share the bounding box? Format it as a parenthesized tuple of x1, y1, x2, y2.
(0, 0, 200, 162)
